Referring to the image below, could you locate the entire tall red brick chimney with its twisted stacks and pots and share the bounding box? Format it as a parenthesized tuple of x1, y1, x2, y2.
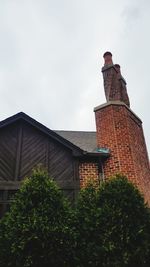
(94, 52, 150, 204)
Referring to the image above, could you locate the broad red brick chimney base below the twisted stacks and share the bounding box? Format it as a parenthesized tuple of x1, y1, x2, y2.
(95, 102, 150, 203)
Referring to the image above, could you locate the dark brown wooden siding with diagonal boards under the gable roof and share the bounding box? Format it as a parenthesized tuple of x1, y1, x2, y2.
(0, 120, 79, 201)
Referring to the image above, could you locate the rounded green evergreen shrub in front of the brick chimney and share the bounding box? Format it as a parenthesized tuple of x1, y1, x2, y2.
(98, 175, 149, 267)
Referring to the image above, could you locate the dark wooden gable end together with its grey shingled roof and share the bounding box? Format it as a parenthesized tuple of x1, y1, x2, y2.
(0, 112, 108, 217)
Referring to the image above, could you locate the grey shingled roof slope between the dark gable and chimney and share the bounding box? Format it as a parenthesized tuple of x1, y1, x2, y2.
(55, 130, 97, 153)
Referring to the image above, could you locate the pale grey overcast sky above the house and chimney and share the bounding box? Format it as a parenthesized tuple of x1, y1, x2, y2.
(0, 0, 150, 157)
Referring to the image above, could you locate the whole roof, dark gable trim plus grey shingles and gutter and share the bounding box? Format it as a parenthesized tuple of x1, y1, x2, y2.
(0, 112, 109, 157)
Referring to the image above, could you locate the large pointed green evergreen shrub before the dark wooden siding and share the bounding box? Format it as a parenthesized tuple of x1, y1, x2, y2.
(0, 170, 72, 267)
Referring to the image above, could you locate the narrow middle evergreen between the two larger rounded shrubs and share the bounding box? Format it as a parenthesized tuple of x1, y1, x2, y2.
(74, 182, 101, 267)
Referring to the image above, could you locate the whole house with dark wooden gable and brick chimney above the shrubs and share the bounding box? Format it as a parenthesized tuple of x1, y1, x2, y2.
(0, 52, 150, 216)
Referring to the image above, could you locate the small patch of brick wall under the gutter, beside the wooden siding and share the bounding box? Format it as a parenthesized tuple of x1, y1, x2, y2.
(79, 162, 99, 187)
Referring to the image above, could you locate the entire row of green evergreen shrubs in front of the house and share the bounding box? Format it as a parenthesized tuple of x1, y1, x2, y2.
(0, 170, 150, 267)
